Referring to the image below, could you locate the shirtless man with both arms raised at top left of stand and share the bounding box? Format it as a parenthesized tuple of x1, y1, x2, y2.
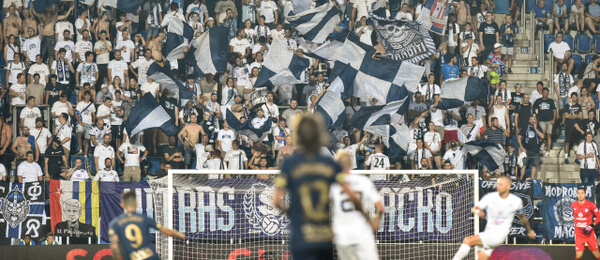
(31, 3, 75, 64)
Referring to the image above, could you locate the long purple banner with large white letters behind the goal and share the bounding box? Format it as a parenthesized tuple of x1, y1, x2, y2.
(150, 179, 473, 242)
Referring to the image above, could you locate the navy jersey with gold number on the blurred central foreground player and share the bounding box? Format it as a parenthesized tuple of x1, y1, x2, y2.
(276, 153, 344, 253)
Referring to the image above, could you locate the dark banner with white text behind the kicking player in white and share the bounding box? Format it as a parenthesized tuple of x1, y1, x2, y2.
(479, 180, 534, 237)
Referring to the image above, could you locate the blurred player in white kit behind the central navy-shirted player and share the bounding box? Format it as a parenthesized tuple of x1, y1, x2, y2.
(329, 149, 383, 260)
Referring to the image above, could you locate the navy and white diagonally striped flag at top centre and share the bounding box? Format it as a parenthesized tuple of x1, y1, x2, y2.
(285, 2, 340, 43)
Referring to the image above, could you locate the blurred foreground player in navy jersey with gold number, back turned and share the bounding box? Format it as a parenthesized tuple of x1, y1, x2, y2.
(273, 115, 362, 260)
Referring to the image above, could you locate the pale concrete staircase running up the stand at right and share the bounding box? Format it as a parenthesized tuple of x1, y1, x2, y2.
(495, 14, 580, 183)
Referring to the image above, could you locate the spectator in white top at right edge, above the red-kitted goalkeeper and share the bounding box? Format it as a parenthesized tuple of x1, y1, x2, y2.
(577, 132, 600, 183)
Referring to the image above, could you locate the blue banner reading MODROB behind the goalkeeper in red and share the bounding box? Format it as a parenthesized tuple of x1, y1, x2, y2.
(542, 183, 594, 241)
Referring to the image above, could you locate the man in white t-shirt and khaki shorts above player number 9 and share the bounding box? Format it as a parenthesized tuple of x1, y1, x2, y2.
(117, 136, 148, 181)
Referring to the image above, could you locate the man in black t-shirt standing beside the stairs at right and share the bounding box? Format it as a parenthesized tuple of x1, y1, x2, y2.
(533, 88, 556, 156)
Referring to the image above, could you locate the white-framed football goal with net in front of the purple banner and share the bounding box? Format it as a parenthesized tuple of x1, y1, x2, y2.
(149, 170, 479, 260)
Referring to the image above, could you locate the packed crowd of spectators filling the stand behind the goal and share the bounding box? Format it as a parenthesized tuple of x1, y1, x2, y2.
(0, 0, 600, 191)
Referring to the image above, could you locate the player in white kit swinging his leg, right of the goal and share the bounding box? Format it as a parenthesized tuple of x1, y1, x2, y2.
(452, 175, 535, 260)
